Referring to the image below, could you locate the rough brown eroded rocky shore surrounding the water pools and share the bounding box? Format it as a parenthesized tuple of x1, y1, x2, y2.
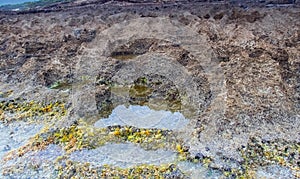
(0, 2, 300, 177)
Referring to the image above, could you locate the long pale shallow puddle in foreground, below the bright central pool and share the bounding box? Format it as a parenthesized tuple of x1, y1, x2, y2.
(70, 143, 176, 168)
